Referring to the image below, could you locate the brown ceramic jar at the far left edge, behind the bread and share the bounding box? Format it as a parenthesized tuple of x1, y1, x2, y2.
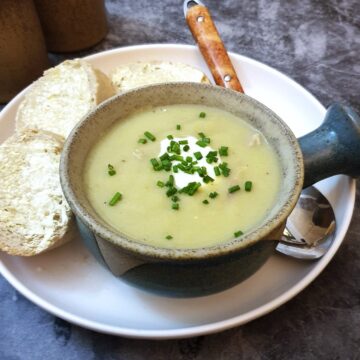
(0, 0, 49, 103)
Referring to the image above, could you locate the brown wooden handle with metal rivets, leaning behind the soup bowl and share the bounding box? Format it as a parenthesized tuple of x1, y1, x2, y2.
(186, 5, 244, 93)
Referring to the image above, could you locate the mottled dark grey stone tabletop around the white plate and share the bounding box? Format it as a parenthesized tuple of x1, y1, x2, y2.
(0, 0, 360, 360)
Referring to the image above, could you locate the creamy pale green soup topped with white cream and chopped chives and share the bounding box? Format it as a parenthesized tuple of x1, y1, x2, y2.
(84, 105, 281, 248)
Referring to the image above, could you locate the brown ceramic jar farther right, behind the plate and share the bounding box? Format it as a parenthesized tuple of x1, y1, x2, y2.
(35, 0, 107, 52)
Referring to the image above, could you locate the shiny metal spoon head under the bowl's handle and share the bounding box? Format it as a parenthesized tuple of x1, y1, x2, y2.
(276, 186, 336, 260)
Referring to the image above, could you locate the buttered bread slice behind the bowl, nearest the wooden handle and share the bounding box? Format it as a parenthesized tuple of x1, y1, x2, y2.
(110, 61, 210, 92)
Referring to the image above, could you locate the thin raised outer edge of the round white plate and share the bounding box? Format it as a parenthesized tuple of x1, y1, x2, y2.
(0, 44, 356, 339)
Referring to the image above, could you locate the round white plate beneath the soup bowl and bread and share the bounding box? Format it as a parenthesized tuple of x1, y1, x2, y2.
(0, 45, 355, 339)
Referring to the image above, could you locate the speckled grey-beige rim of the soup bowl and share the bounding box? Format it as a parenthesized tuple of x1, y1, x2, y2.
(60, 82, 304, 263)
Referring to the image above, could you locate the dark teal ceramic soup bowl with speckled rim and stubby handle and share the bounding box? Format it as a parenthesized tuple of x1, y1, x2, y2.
(60, 83, 360, 297)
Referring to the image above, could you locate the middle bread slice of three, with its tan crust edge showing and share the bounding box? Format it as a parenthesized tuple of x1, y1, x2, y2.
(16, 59, 115, 137)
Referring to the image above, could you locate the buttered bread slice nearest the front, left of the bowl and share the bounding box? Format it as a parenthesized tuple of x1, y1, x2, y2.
(0, 130, 75, 256)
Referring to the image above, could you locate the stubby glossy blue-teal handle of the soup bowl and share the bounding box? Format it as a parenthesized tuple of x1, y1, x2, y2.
(298, 104, 360, 188)
